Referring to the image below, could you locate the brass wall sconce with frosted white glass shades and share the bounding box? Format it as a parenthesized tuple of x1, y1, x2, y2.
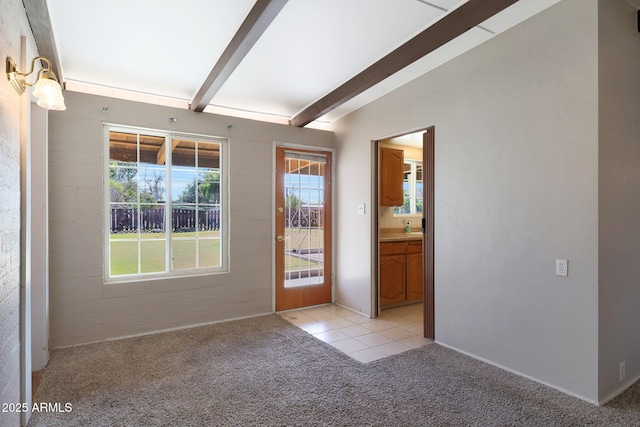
(7, 56, 67, 111)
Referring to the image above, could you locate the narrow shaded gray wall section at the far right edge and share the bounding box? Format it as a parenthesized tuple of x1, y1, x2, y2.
(598, 0, 640, 400)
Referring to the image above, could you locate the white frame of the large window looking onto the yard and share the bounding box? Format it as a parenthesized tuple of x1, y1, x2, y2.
(102, 123, 229, 284)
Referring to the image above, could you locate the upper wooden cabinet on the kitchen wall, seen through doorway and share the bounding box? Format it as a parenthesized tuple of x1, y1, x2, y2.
(379, 147, 404, 206)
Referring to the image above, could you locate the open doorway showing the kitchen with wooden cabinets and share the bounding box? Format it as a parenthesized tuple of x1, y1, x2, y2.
(374, 126, 435, 339)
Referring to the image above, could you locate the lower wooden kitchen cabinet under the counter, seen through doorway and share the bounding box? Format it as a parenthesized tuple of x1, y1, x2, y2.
(379, 240, 424, 308)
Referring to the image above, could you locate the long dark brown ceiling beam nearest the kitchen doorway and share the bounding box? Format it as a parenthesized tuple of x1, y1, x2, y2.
(289, 0, 518, 127)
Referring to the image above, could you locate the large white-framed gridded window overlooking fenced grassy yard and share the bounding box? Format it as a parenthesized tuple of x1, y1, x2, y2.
(105, 126, 226, 280)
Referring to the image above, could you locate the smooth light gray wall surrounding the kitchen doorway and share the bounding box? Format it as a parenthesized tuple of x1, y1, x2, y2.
(334, 0, 598, 401)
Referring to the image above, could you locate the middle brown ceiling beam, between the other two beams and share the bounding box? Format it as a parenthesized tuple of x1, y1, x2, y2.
(189, 0, 288, 112)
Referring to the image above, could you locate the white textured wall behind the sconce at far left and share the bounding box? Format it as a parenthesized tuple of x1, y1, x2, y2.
(0, 0, 34, 426)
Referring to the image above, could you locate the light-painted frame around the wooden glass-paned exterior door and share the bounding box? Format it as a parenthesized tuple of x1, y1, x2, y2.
(271, 141, 337, 313)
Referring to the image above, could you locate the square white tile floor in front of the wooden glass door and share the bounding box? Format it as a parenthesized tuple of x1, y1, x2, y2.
(278, 304, 433, 363)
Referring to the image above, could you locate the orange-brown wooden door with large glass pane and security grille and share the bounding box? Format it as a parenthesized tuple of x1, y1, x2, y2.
(275, 147, 332, 311)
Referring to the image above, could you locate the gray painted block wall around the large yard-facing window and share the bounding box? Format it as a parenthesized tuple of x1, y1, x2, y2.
(49, 92, 334, 347)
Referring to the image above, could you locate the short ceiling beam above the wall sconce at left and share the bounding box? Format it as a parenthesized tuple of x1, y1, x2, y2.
(23, 0, 64, 87)
